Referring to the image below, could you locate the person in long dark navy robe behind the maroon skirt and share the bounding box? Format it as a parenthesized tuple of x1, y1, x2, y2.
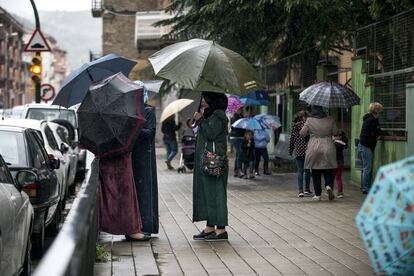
(132, 82, 159, 236)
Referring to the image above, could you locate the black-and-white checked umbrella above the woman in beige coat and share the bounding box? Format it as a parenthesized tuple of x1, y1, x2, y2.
(299, 81, 359, 108)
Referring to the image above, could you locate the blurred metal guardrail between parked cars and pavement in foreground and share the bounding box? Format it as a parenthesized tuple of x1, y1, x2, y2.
(33, 159, 99, 276)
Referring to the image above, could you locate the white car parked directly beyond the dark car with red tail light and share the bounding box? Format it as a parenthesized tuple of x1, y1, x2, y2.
(0, 119, 71, 212)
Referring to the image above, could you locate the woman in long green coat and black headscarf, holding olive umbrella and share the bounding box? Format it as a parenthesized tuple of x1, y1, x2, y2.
(193, 92, 228, 241)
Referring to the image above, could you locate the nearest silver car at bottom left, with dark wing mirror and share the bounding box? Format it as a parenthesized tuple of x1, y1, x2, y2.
(0, 155, 36, 276)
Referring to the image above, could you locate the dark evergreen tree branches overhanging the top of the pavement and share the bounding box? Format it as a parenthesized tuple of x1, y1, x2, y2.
(157, 0, 413, 62)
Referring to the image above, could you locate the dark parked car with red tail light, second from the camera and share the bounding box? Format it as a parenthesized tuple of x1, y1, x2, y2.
(0, 126, 61, 257)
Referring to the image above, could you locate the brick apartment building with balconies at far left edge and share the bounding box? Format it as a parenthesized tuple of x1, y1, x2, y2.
(0, 7, 29, 108)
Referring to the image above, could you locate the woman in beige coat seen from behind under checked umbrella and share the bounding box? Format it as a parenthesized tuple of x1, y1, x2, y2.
(299, 106, 338, 200)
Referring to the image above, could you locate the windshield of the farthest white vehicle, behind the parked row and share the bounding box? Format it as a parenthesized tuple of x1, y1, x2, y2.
(26, 108, 78, 128)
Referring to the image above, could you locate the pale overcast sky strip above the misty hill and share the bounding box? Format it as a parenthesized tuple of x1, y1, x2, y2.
(0, 0, 91, 17)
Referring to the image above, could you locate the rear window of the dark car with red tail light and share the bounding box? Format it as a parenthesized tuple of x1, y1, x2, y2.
(0, 130, 27, 166)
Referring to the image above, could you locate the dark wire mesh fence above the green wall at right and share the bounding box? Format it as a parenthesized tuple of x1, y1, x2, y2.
(355, 10, 414, 136)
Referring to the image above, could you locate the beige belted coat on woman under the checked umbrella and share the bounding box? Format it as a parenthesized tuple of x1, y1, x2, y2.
(299, 116, 338, 170)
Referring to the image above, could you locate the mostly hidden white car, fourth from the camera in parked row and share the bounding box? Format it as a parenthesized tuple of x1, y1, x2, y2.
(48, 121, 78, 189)
